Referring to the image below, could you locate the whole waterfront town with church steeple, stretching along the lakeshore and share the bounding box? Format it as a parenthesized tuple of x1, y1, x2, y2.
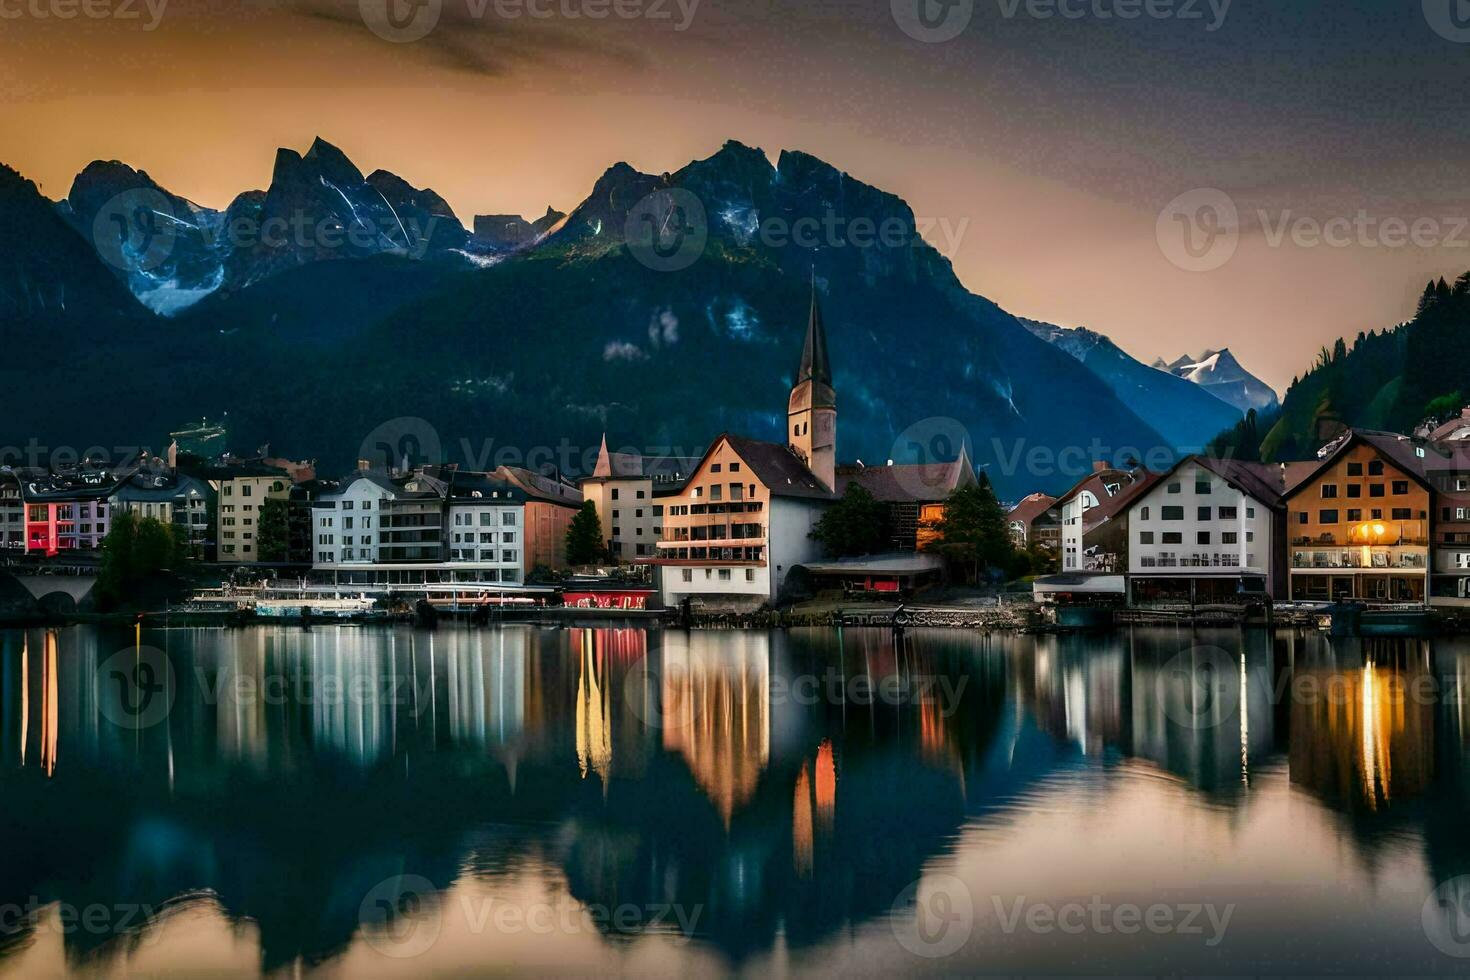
(0, 291, 1470, 628)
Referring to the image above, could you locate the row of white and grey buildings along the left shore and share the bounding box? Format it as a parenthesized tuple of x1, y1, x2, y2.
(0, 451, 582, 585)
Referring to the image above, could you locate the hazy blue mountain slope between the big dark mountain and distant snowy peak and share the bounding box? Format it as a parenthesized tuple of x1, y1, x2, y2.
(1022, 319, 1241, 447)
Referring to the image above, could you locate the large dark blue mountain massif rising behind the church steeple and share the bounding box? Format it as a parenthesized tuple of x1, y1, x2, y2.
(0, 141, 1194, 498)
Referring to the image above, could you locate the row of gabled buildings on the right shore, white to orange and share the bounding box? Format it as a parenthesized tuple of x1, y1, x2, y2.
(1010, 410, 1470, 605)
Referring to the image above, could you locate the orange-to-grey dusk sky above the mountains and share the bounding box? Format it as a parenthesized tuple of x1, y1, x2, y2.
(0, 0, 1470, 389)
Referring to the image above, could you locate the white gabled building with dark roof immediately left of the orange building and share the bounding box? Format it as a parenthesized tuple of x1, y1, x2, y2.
(1127, 455, 1285, 602)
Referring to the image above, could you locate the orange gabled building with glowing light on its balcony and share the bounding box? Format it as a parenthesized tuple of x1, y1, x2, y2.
(1286, 430, 1432, 602)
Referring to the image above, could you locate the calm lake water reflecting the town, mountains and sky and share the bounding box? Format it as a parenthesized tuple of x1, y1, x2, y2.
(0, 627, 1470, 977)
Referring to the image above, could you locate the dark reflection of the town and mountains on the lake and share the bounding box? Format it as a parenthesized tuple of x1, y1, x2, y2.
(0, 629, 1470, 971)
